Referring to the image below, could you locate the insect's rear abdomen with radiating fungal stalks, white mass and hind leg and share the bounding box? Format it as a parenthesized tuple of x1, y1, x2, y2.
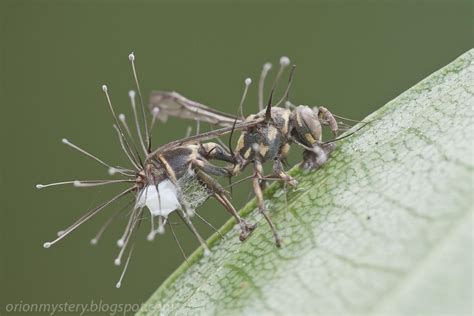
(36, 53, 255, 287)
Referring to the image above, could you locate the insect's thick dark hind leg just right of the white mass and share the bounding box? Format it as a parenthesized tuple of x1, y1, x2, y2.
(195, 164, 257, 241)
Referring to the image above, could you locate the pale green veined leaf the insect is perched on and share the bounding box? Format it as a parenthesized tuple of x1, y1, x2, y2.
(139, 50, 474, 315)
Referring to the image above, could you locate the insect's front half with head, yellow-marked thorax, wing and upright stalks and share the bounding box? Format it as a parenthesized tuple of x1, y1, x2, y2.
(149, 57, 364, 247)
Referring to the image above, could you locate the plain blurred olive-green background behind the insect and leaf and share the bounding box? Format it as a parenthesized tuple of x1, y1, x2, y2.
(0, 0, 472, 314)
